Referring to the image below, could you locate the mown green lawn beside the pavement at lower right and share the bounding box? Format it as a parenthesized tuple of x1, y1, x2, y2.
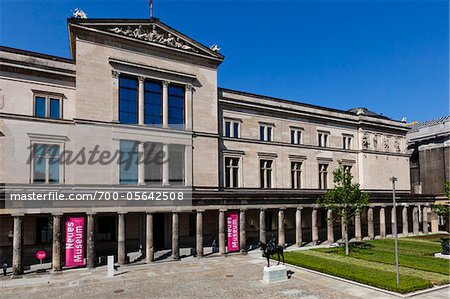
(285, 238, 450, 293)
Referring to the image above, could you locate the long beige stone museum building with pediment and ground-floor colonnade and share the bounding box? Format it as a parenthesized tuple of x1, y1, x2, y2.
(0, 18, 437, 274)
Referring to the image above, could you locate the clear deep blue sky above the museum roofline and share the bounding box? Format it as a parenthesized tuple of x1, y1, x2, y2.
(0, 0, 449, 121)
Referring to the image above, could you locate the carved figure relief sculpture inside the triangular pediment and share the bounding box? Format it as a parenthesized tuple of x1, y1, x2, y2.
(108, 25, 198, 53)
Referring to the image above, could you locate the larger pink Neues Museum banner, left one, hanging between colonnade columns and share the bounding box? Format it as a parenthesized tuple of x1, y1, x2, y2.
(66, 217, 84, 267)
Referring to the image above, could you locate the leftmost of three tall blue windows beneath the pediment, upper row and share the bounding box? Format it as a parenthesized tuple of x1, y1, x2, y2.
(119, 76, 138, 124)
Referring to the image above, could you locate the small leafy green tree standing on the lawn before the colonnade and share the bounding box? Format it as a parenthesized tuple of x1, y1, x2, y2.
(317, 161, 369, 255)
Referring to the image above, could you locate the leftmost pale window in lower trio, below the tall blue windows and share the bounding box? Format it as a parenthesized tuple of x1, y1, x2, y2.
(120, 140, 138, 185)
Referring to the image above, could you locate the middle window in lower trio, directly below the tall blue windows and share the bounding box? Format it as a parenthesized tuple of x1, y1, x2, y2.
(144, 142, 163, 185)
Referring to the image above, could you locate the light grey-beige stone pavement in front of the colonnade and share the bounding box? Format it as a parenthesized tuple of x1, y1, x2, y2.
(0, 252, 449, 299)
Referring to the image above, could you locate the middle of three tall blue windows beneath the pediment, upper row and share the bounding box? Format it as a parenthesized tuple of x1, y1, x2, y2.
(144, 81, 162, 126)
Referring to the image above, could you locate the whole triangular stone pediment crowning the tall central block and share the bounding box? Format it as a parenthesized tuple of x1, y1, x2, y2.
(68, 18, 223, 61)
